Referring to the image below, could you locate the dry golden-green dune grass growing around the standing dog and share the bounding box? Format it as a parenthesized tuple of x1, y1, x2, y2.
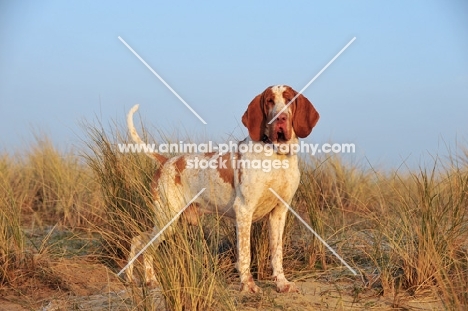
(0, 124, 468, 310)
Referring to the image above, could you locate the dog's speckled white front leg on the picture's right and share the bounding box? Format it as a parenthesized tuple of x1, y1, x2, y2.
(268, 203, 298, 293)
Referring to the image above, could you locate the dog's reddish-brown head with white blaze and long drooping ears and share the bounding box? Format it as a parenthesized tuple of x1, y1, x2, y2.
(242, 85, 319, 154)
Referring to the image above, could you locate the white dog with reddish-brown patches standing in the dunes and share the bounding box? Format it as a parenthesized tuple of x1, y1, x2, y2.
(126, 85, 319, 293)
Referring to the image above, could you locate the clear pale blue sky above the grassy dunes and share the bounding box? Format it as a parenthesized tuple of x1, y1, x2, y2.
(0, 1, 468, 166)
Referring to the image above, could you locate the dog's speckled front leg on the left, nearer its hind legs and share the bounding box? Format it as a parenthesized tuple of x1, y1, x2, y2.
(236, 209, 261, 293)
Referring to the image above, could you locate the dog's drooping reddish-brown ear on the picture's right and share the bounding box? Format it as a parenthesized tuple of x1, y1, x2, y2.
(292, 94, 320, 138)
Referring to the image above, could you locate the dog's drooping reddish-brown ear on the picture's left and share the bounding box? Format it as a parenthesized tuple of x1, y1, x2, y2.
(242, 93, 266, 141)
